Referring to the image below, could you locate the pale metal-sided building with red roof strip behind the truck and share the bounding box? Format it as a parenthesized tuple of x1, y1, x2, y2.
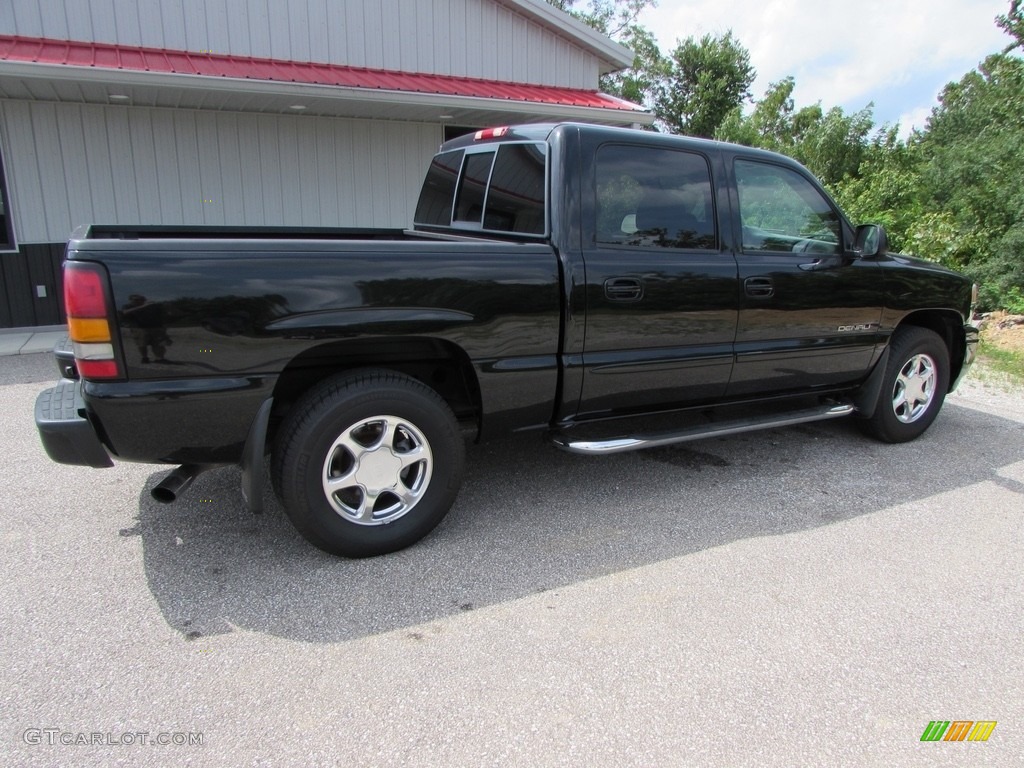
(0, 0, 653, 328)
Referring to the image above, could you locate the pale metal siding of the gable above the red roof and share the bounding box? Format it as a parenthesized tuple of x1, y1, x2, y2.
(0, 0, 599, 88)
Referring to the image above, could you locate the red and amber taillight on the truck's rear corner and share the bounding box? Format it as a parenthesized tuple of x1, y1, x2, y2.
(63, 261, 121, 379)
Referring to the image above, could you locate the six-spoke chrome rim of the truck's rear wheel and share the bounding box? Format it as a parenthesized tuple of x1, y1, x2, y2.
(322, 416, 434, 525)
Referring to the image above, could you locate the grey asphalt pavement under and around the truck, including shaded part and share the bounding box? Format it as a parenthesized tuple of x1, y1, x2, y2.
(0, 354, 1024, 768)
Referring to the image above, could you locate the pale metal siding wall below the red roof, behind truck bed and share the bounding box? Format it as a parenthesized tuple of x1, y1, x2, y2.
(0, 100, 441, 243)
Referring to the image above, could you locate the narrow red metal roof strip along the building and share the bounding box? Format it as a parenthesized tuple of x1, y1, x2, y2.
(0, 35, 640, 112)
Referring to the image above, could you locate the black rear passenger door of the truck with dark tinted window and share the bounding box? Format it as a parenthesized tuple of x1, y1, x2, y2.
(579, 140, 738, 417)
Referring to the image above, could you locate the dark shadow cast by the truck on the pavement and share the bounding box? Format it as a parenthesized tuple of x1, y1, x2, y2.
(132, 403, 1024, 643)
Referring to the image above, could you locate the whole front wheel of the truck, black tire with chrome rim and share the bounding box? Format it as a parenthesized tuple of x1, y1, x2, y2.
(860, 326, 949, 442)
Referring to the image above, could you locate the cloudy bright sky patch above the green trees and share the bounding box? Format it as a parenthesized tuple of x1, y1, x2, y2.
(639, 0, 1010, 136)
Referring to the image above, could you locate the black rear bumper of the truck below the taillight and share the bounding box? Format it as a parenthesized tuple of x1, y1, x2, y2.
(36, 380, 114, 468)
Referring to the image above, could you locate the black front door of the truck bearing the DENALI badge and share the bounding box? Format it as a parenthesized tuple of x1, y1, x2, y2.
(728, 157, 884, 396)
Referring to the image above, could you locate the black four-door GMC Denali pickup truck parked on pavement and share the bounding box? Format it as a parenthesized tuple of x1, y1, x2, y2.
(36, 124, 978, 557)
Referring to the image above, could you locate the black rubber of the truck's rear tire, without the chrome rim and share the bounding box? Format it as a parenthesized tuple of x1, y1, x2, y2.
(282, 377, 464, 557)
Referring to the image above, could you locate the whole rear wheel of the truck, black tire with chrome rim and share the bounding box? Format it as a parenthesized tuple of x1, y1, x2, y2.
(271, 370, 465, 557)
